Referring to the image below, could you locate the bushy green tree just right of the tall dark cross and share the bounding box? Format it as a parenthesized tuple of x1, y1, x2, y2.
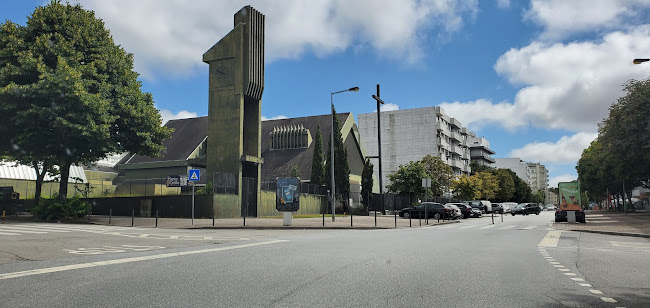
(387, 161, 428, 200)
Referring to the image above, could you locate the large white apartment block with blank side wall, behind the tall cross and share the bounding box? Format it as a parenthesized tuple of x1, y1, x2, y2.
(359, 107, 470, 191)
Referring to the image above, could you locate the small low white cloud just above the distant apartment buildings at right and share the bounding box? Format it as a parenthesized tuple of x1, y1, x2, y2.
(510, 133, 598, 164)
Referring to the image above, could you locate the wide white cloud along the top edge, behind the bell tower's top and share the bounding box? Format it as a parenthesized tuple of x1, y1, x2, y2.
(77, 0, 478, 79)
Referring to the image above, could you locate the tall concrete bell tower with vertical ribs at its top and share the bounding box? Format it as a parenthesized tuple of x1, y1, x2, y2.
(203, 6, 264, 216)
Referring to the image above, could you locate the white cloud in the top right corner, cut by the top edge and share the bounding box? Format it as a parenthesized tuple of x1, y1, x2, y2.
(524, 0, 650, 40)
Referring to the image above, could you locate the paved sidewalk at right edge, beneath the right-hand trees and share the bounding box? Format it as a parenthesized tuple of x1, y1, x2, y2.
(553, 211, 650, 238)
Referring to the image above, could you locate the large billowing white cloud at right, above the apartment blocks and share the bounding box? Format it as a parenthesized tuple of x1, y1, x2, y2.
(440, 25, 650, 132)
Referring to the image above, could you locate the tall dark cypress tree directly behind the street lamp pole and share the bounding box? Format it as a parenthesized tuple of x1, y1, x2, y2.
(325, 109, 350, 200)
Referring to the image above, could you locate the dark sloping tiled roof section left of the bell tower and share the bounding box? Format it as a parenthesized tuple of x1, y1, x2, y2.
(127, 117, 208, 164)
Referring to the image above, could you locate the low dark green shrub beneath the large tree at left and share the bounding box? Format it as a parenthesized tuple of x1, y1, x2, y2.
(33, 195, 90, 221)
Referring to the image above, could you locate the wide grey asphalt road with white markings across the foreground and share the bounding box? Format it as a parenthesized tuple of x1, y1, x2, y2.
(0, 212, 650, 307)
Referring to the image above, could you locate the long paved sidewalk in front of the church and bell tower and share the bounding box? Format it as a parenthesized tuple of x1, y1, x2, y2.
(3, 214, 459, 229)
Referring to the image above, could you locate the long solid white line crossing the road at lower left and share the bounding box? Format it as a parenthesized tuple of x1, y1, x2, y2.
(0, 240, 287, 280)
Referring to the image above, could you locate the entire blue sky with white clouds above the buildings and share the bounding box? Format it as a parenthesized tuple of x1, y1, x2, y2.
(0, 0, 650, 187)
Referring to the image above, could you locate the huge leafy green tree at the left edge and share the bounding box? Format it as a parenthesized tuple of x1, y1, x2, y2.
(0, 1, 169, 199)
